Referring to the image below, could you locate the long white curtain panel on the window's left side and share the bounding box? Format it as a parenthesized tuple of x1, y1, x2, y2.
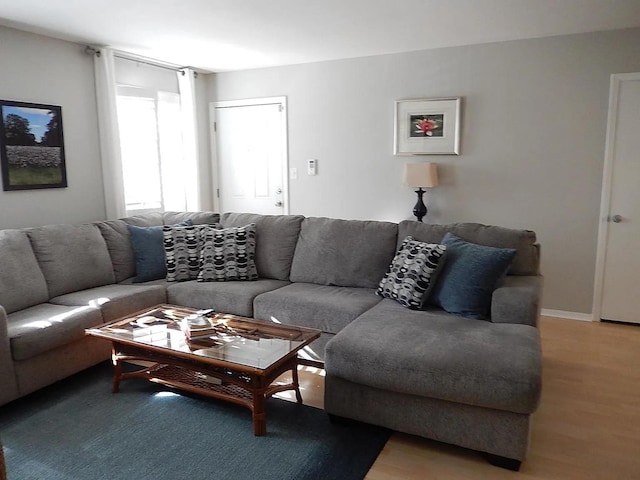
(93, 48, 126, 220)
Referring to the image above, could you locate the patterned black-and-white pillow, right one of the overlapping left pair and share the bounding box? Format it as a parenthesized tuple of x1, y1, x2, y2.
(198, 223, 258, 282)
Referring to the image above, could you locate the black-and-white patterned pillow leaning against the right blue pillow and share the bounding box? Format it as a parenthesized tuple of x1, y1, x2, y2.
(376, 237, 447, 310)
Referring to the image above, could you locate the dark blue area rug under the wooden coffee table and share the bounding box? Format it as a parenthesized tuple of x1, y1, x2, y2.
(0, 363, 390, 480)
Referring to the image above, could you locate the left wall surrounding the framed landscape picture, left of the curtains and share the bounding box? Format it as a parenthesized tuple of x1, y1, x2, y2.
(0, 27, 105, 229)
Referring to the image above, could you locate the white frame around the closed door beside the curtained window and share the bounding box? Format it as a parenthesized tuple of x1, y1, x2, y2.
(209, 96, 289, 215)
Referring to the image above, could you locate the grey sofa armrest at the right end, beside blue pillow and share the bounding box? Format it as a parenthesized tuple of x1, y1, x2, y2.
(491, 275, 543, 327)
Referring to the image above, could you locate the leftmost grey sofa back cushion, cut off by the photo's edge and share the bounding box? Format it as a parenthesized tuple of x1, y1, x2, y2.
(0, 230, 49, 313)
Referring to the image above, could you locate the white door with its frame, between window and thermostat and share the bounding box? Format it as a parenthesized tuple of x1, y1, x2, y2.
(214, 97, 288, 214)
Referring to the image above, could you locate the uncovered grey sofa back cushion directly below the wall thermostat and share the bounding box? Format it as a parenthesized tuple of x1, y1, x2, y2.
(291, 217, 398, 288)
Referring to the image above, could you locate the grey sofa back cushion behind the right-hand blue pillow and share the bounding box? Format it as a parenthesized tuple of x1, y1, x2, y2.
(398, 220, 540, 275)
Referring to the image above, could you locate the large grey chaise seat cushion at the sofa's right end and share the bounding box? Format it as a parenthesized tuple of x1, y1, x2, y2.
(325, 299, 542, 414)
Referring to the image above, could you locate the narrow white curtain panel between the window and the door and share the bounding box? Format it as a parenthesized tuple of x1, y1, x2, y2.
(177, 68, 201, 211)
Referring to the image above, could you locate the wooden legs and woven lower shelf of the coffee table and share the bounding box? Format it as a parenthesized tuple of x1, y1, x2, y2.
(113, 355, 302, 436)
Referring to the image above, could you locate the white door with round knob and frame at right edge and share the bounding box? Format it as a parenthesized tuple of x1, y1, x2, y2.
(600, 74, 640, 323)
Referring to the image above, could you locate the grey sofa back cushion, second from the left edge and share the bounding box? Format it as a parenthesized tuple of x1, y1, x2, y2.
(27, 224, 115, 297)
